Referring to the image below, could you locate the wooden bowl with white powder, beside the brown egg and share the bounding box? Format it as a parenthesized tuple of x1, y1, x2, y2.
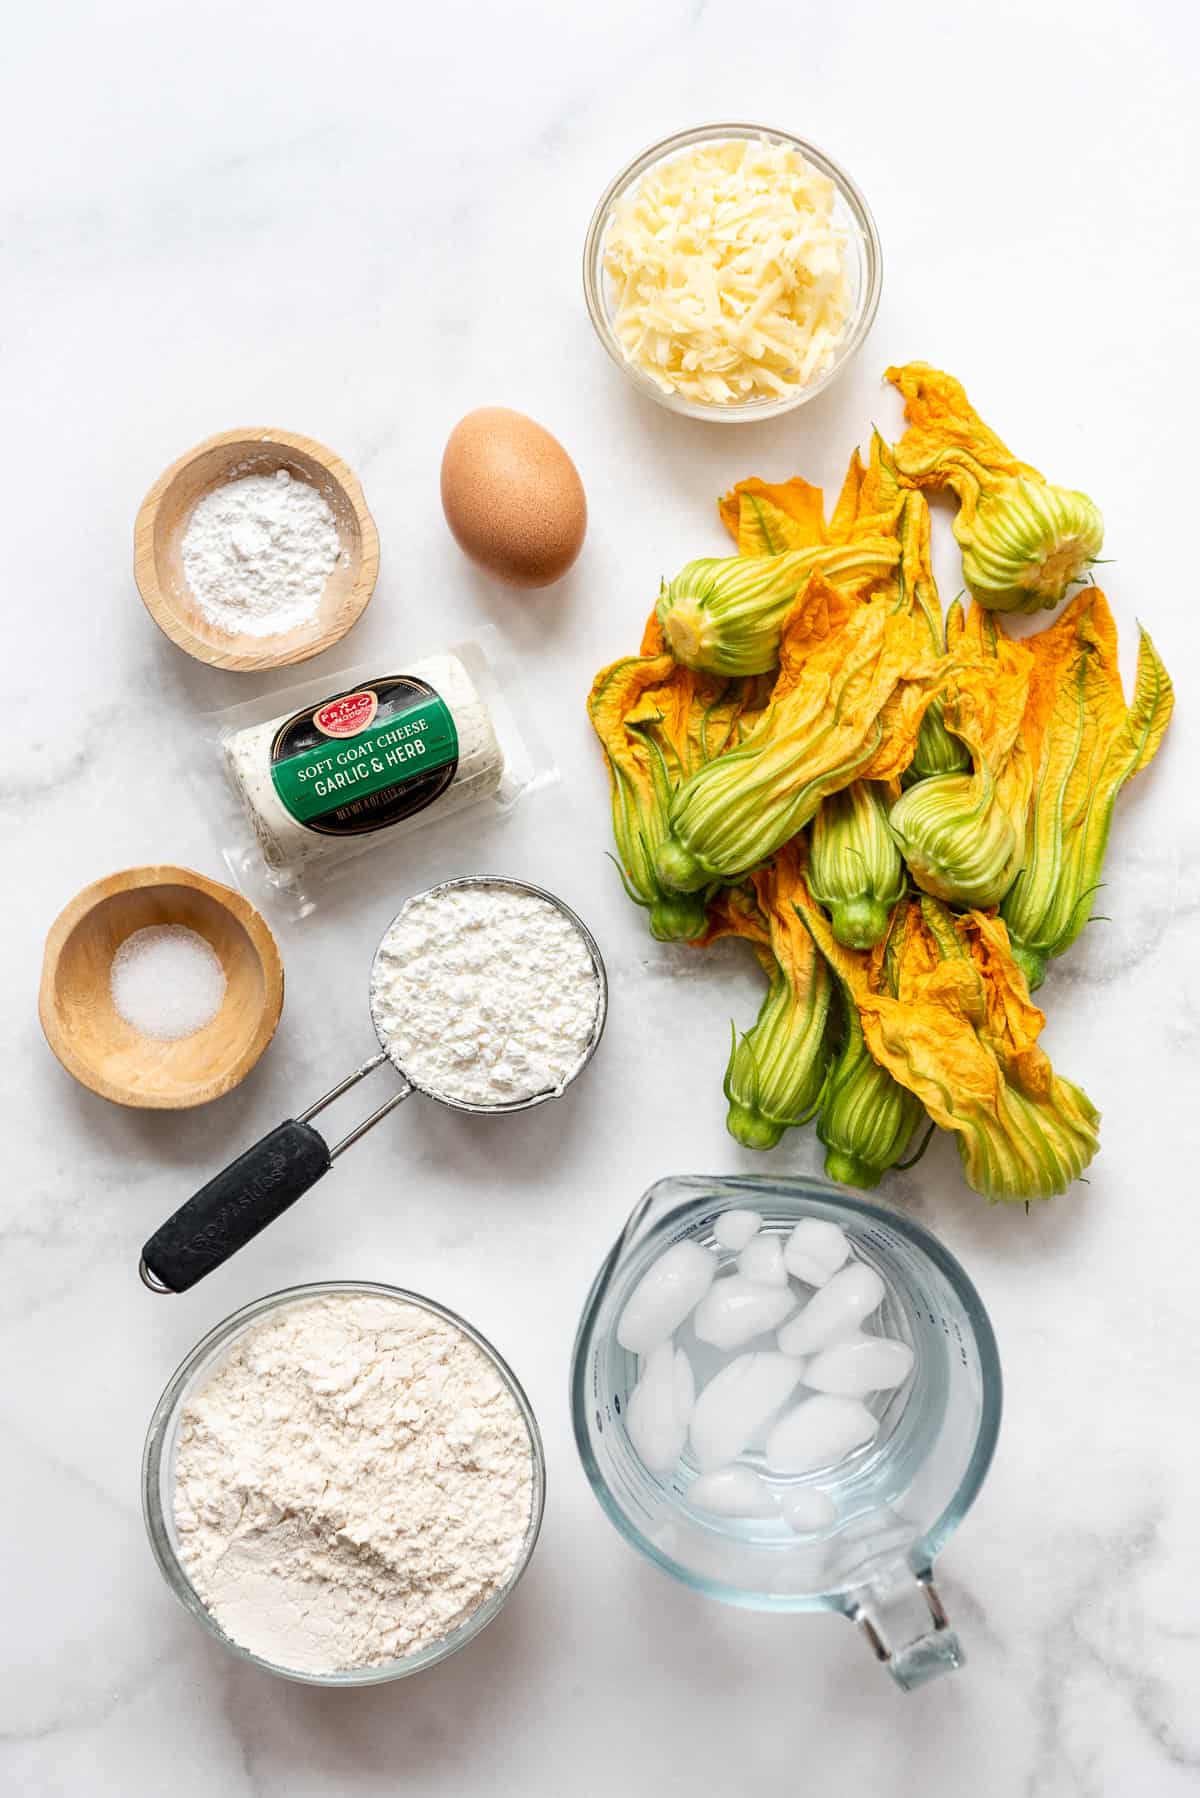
(133, 430, 380, 672)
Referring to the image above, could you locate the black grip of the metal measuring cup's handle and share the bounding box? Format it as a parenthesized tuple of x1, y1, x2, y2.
(140, 1118, 329, 1293)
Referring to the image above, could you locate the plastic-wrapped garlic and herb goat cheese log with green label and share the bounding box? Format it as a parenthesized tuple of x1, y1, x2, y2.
(221, 651, 506, 888)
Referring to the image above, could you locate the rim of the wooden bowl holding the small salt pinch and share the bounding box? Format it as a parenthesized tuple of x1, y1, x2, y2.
(38, 863, 284, 1111)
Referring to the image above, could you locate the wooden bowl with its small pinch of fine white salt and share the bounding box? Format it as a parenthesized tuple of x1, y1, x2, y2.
(38, 867, 282, 1111)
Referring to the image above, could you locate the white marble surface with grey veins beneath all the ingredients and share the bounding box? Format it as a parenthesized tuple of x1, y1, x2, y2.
(0, 0, 1200, 1798)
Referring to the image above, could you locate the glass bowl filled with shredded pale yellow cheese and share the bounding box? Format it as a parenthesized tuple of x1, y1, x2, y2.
(583, 124, 882, 424)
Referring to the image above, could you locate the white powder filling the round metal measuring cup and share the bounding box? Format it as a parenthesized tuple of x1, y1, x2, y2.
(371, 886, 599, 1106)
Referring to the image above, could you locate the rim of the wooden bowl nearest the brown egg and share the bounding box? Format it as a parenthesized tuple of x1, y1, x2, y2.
(133, 426, 380, 674)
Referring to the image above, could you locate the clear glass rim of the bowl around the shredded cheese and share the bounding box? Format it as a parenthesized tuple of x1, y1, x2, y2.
(583, 120, 883, 424)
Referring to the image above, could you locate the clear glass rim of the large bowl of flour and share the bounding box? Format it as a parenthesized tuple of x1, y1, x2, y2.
(142, 1280, 545, 1687)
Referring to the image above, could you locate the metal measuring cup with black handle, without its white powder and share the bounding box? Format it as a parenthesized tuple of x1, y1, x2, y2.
(139, 874, 608, 1293)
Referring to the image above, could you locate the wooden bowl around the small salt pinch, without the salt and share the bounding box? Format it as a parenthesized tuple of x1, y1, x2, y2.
(38, 867, 282, 1111)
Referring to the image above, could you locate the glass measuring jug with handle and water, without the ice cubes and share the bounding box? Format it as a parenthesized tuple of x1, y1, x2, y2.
(570, 1176, 1000, 1690)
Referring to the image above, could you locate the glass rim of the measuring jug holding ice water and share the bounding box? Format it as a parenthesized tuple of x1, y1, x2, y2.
(570, 1174, 1004, 1613)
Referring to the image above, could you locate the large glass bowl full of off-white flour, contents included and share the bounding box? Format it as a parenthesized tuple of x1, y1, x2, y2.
(142, 1280, 545, 1687)
